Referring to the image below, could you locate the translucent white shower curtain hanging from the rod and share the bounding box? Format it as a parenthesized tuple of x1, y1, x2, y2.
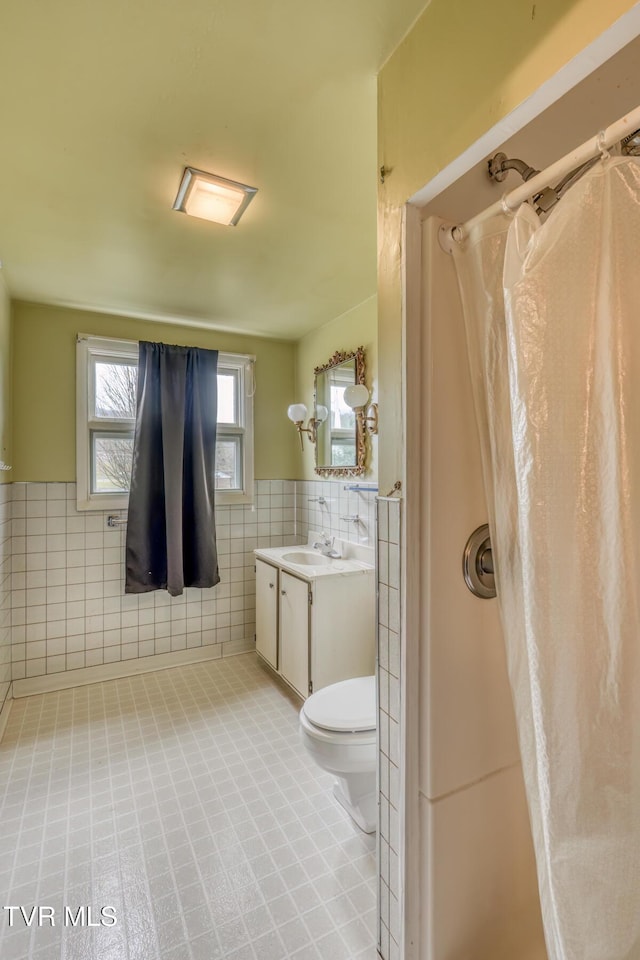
(455, 157, 640, 960)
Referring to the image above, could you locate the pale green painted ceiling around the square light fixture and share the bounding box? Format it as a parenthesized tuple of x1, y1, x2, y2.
(0, 0, 425, 339)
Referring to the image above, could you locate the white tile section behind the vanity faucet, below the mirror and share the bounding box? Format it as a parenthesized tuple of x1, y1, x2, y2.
(296, 480, 377, 547)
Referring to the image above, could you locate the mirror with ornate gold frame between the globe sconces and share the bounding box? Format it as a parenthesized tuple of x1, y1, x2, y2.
(313, 347, 366, 477)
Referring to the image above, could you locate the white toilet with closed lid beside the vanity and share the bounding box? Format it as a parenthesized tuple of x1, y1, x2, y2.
(300, 677, 378, 833)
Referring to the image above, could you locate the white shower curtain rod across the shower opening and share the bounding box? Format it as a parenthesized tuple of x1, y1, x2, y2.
(439, 106, 640, 253)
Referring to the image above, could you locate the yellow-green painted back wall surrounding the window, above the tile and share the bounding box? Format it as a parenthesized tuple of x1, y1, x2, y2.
(11, 300, 300, 481)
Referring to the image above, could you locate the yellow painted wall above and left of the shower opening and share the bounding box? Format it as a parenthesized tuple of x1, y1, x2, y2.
(378, 0, 635, 488)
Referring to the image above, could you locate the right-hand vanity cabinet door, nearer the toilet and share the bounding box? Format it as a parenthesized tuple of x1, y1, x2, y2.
(280, 570, 309, 698)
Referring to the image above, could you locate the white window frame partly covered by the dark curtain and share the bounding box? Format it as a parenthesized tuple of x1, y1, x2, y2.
(76, 334, 255, 510)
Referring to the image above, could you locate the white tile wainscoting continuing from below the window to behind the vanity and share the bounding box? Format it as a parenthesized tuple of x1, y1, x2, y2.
(8, 480, 375, 688)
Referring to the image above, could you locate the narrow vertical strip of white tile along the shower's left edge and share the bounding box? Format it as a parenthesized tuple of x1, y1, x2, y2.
(378, 497, 401, 960)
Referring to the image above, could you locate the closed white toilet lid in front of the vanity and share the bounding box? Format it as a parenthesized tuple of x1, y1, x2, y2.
(302, 677, 376, 733)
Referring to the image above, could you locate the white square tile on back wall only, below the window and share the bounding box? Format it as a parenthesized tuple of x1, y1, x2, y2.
(10, 480, 297, 691)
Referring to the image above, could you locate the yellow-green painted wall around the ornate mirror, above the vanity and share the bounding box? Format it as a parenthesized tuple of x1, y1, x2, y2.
(291, 296, 378, 482)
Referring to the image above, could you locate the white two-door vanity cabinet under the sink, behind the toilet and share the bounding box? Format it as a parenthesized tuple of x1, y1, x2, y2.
(256, 547, 376, 699)
